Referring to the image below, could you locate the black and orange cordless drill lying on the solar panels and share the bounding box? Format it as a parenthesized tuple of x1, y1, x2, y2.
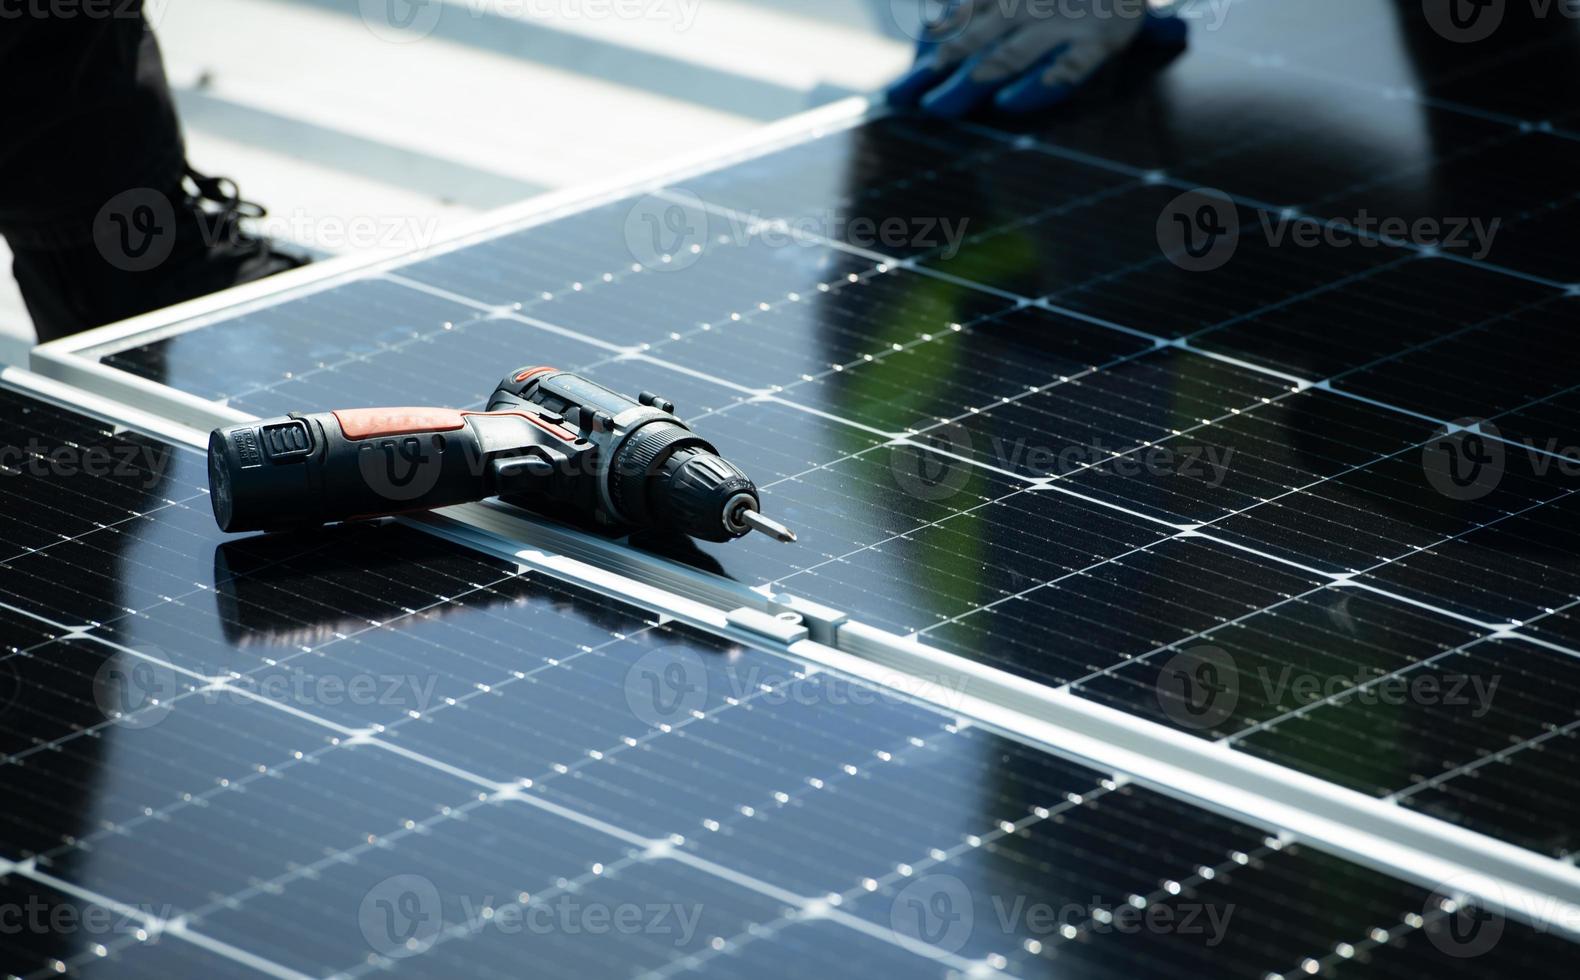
(209, 367, 795, 542)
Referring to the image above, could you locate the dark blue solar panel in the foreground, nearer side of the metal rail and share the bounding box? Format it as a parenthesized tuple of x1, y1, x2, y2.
(0, 392, 1561, 975)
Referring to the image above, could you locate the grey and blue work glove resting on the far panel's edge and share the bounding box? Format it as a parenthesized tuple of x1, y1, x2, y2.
(888, 0, 1187, 119)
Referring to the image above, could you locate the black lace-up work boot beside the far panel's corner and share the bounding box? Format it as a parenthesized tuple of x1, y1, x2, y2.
(13, 168, 310, 343)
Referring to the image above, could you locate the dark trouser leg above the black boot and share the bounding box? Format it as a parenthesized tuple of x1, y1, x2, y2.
(0, 0, 185, 340)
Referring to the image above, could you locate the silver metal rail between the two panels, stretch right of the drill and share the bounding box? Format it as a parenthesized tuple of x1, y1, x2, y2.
(426, 504, 1580, 942)
